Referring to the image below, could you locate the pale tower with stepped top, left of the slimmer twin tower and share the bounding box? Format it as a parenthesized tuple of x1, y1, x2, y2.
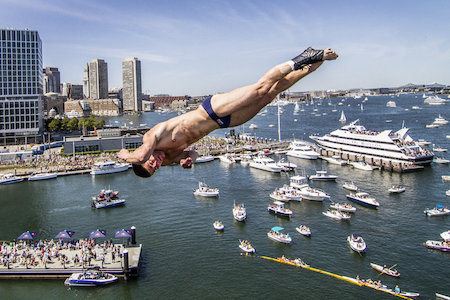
(83, 59, 108, 99)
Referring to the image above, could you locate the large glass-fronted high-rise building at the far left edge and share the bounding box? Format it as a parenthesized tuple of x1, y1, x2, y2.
(0, 29, 43, 145)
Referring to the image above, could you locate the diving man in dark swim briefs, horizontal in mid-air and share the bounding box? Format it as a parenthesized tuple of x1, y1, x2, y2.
(118, 47, 338, 177)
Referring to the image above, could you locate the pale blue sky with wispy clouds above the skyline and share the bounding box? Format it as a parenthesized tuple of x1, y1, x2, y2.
(0, 0, 450, 96)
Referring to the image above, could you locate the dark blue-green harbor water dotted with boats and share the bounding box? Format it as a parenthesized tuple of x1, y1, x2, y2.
(0, 95, 450, 299)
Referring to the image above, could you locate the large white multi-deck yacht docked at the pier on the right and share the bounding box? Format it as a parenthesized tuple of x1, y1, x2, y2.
(310, 119, 434, 165)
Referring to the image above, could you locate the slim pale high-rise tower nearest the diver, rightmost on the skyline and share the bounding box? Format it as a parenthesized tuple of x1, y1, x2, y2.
(122, 57, 142, 111)
